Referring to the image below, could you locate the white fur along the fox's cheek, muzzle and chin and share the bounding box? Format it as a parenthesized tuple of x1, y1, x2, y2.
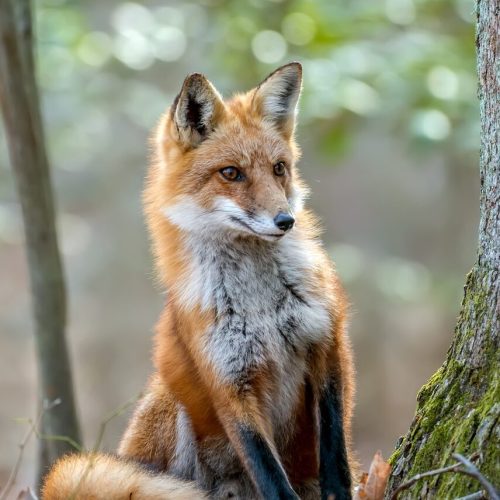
(162, 196, 285, 241)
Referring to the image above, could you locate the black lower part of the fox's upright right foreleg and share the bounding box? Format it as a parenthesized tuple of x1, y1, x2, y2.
(319, 380, 351, 500)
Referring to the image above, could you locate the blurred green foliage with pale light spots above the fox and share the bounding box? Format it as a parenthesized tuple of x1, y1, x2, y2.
(31, 0, 478, 168)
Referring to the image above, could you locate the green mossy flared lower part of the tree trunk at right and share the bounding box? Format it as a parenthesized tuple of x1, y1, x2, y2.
(390, 267, 500, 498)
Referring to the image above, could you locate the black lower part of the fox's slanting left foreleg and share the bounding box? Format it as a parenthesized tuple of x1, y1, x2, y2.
(237, 426, 298, 500)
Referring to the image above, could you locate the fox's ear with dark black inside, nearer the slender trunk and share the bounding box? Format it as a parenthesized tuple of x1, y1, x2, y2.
(172, 73, 224, 147)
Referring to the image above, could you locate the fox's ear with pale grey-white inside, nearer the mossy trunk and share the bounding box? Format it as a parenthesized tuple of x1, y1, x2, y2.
(253, 62, 302, 139)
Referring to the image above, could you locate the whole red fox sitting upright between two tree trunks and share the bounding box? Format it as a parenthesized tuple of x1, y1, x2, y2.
(43, 62, 354, 500)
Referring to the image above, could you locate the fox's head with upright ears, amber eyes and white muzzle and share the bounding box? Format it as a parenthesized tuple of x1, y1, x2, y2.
(145, 62, 304, 249)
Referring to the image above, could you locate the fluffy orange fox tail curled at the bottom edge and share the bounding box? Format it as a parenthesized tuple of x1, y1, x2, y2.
(42, 453, 207, 500)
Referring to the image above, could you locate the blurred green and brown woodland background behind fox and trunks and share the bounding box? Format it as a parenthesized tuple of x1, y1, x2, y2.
(0, 0, 479, 490)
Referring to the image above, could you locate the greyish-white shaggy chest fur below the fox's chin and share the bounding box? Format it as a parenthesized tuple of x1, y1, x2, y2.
(183, 233, 330, 421)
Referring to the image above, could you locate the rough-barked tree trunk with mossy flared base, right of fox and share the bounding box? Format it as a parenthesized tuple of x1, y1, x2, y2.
(387, 0, 500, 498)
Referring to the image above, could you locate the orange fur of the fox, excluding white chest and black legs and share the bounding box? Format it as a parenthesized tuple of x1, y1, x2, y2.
(44, 64, 354, 500)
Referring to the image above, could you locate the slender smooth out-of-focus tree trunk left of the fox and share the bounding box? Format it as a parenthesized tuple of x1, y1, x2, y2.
(0, 0, 80, 488)
